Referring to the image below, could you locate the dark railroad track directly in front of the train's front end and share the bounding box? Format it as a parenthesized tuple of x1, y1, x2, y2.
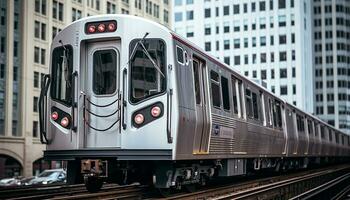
(0, 184, 143, 200)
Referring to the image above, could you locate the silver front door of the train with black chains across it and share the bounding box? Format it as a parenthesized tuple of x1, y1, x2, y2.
(81, 41, 121, 147)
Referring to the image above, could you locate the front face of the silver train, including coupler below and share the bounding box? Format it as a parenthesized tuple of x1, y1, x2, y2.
(39, 15, 176, 191)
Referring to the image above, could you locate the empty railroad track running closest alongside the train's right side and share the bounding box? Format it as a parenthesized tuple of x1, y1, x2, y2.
(161, 165, 350, 200)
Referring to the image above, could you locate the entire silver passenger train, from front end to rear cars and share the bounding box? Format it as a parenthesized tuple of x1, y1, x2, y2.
(39, 15, 350, 191)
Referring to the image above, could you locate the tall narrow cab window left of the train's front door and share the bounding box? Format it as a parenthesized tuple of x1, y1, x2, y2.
(51, 45, 73, 106)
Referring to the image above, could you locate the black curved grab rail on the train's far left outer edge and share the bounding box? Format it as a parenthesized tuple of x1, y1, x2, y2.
(38, 74, 51, 144)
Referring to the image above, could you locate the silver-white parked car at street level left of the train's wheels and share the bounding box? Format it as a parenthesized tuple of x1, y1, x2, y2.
(28, 169, 66, 185)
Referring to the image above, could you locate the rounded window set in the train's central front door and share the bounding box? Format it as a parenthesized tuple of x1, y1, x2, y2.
(92, 49, 117, 95)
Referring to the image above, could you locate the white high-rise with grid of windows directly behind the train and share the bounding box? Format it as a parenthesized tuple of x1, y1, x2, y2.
(173, 0, 314, 113)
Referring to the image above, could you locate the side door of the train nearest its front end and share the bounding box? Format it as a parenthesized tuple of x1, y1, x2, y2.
(193, 57, 210, 153)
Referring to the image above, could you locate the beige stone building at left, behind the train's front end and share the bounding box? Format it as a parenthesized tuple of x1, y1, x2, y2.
(0, 0, 171, 178)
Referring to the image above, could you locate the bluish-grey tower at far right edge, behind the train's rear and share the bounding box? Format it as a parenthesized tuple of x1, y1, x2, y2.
(312, 0, 350, 134)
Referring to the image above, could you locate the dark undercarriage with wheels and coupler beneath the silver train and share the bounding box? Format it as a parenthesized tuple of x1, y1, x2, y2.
(63, 157, 341, 192)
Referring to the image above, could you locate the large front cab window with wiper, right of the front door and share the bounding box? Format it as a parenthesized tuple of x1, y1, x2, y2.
(130, 39, 166, 103)
